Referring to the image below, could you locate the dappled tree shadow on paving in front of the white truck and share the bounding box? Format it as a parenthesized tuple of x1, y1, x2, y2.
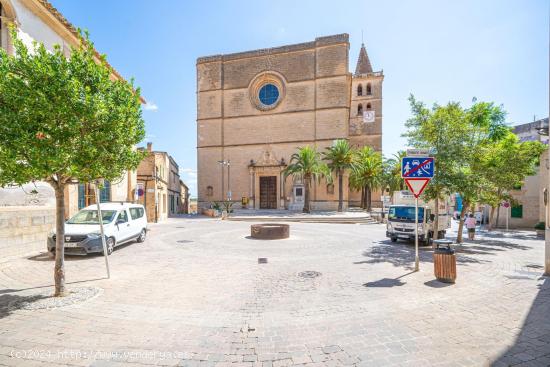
(354, 240, 484, 270)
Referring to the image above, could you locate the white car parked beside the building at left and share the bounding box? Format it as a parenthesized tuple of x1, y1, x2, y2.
(47, 203, 147, 255)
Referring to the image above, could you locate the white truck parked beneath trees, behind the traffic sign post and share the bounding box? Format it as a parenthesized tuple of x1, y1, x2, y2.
(386, 191, 451, 245)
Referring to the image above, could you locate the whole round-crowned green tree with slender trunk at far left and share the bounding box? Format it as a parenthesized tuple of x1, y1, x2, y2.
(0, 29, 145, 296)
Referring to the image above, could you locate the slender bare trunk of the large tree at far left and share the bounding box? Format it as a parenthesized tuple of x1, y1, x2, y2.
(54, 182, 67, 297)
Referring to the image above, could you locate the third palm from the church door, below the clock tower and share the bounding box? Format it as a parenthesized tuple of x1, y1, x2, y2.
(350, 147, 384, 211)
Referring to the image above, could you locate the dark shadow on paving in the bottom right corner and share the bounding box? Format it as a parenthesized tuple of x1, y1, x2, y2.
(491, 277, 550, 367)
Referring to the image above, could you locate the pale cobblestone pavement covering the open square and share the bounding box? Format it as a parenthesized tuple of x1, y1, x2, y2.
(0, 218, 550, 367)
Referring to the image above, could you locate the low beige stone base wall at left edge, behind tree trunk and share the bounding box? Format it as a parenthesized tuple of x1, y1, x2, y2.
(0, 206, 55, 262)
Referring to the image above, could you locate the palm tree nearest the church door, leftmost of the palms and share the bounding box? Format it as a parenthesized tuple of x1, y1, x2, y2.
(283, 145, 332, 213)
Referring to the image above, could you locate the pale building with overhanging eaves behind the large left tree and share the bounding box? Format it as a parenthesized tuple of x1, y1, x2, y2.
(0, 0, 137, 260)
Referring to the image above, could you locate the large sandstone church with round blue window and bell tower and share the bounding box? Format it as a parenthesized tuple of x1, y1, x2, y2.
(197, 34, 384, 210)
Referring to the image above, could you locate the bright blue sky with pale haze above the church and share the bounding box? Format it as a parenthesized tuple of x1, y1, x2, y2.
(50, 0, 550, 196)
